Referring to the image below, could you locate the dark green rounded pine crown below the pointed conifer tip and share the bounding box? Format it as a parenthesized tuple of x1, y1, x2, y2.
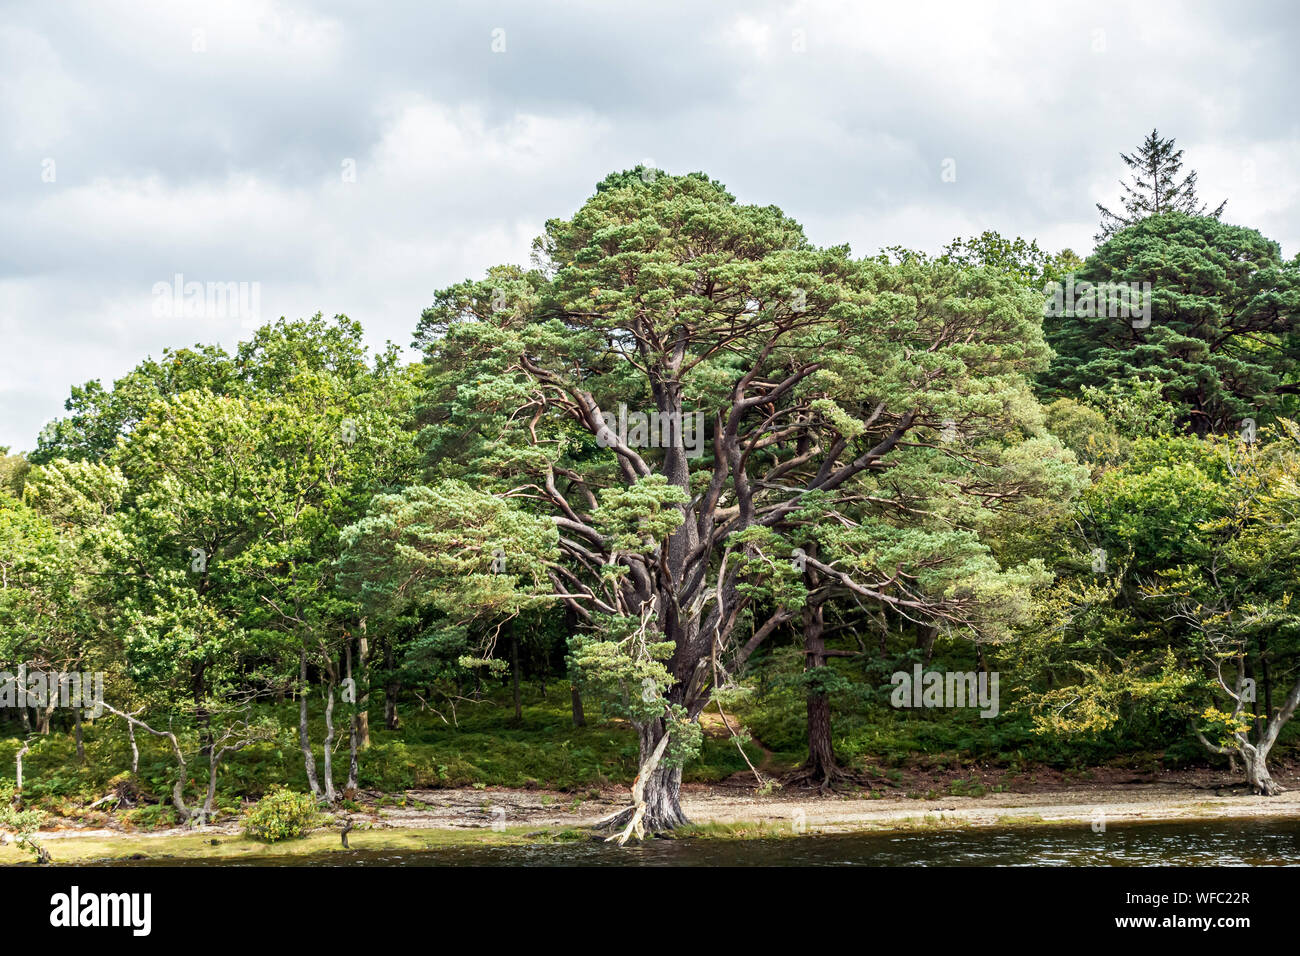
(1041, 212, 1300, 434)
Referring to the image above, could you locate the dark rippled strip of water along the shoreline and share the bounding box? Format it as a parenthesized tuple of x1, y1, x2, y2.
(101, 818, 1300, 866)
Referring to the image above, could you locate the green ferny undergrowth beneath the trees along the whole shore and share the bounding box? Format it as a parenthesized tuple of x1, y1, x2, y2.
(0, 683, 1296, 830)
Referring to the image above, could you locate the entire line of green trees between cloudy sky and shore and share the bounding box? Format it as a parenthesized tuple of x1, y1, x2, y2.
(0, 133, 1300, 836)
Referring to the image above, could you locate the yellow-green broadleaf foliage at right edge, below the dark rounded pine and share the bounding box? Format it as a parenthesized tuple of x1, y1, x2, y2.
(1019, 420, 1300, 775)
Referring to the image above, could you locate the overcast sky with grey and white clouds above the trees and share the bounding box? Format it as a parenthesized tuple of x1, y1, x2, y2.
(0, 0, 1300, 450)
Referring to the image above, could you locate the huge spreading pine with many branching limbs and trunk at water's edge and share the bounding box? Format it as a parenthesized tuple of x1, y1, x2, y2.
(416, 169, 1075, 829)
